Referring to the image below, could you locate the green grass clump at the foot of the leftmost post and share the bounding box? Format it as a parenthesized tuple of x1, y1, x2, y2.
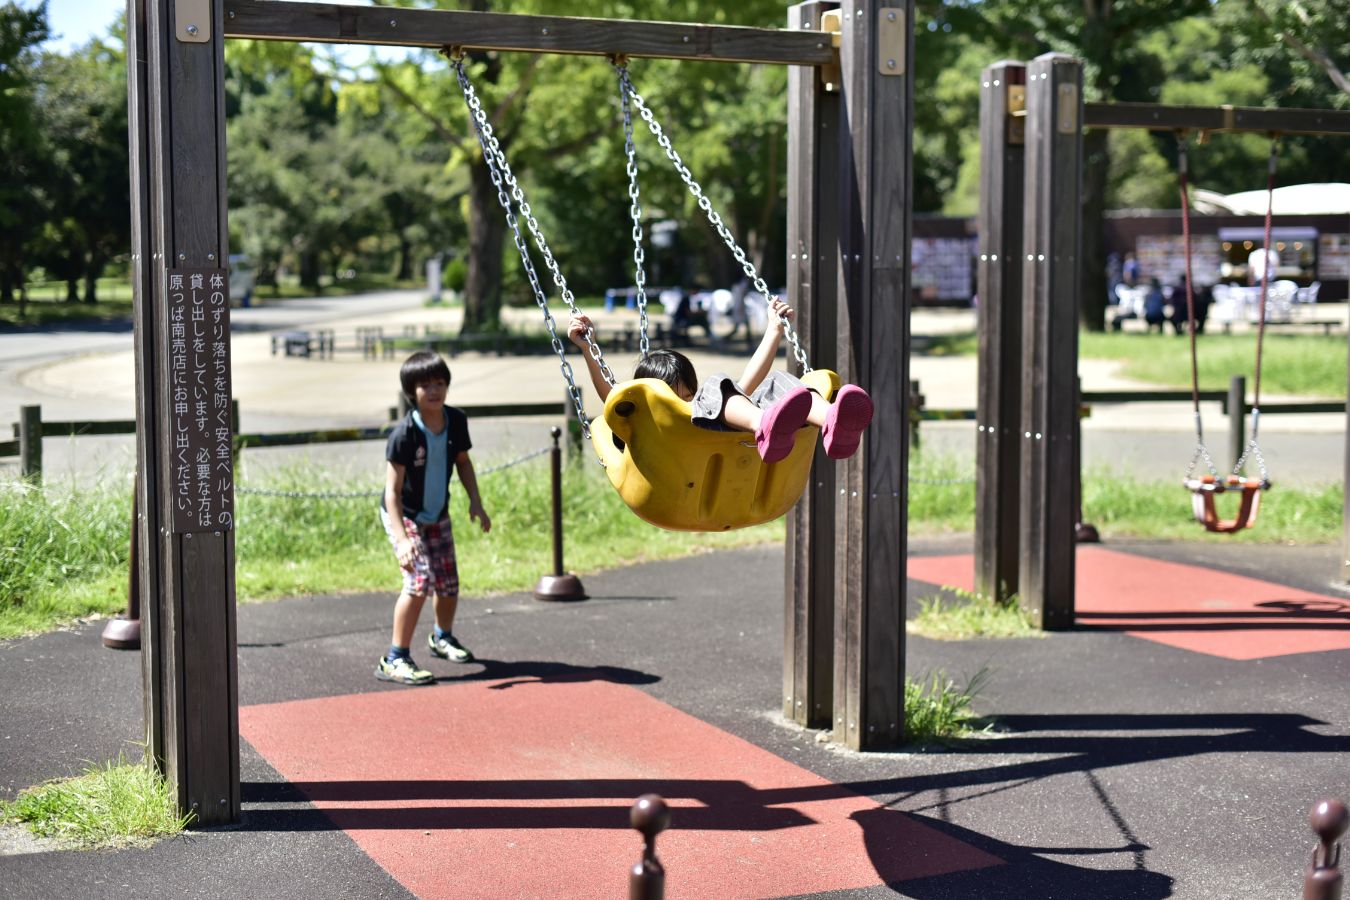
(0, 754, 193, 849)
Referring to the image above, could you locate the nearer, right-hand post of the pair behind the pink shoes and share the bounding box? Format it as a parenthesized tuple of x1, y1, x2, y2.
(832, 0, 914, 750)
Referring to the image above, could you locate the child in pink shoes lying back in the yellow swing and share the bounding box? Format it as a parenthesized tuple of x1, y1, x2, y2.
(567, 297, 872, 463)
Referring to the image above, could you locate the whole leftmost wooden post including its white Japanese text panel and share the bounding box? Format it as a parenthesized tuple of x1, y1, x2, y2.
(127, 0, 239, 826)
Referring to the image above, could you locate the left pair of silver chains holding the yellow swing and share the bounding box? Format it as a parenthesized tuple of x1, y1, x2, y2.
(450, 54, 614, 440)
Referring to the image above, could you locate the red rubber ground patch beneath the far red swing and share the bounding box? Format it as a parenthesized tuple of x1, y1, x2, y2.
(909, 546, 1350, 660)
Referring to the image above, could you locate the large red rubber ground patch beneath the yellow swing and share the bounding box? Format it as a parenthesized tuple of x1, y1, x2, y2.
(239, 680, 1002, 897)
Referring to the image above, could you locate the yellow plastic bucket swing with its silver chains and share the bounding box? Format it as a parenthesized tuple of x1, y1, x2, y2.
(444, 49, 840, 532)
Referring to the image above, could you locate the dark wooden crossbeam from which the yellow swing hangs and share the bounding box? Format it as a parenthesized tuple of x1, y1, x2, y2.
(224, 0, 836, 66)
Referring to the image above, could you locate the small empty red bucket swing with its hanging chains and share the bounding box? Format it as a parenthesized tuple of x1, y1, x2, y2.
(1177, 135, 1278, 534)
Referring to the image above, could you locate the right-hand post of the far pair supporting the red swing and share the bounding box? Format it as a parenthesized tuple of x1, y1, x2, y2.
(1018, 53, 1083, 629)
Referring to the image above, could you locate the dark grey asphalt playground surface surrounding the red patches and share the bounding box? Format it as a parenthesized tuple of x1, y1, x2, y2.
(0, 536, 1350, 900)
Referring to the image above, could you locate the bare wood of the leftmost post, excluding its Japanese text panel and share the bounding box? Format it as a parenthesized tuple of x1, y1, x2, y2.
(128, 0, 239, 826)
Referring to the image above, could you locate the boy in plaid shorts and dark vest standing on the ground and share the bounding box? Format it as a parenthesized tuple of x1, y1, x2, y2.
(375, 351, 491, 684)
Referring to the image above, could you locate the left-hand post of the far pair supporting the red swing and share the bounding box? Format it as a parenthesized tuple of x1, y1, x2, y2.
(975, 61, 1026, 600)
